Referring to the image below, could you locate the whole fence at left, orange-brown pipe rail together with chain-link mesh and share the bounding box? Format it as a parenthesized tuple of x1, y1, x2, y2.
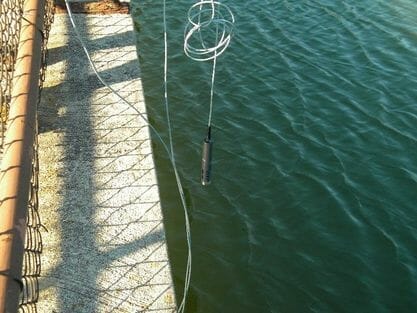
(0, 0, 54, 313)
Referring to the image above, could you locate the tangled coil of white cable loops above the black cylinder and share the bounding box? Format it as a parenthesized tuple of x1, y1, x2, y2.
(184, 0, 235, 61)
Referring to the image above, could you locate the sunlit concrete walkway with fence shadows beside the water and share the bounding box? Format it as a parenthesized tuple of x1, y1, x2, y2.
(38, 10, 175, 313)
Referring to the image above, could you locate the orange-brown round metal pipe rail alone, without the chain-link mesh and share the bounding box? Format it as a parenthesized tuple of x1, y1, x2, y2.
(0, 0, 44, 313)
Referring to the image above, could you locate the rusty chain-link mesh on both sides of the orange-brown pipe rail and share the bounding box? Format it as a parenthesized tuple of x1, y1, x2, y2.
(0, 0, 54, 312)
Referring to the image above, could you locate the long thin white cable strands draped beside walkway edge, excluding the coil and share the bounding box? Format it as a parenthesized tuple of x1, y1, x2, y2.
(65, 0, 192, 313)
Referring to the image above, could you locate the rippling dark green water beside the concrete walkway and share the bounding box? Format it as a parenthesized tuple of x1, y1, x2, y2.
(132, 0, 417, 313)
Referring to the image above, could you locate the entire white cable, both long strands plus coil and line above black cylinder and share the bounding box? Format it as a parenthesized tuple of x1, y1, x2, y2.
(65, 0, 235, 313)
